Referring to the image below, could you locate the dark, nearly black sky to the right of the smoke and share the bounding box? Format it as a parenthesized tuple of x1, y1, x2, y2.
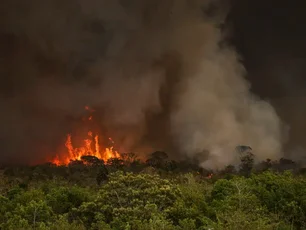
(228, 0, 306, 155)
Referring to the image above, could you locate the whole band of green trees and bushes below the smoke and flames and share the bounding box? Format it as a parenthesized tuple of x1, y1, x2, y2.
(0, 152, 306, 230)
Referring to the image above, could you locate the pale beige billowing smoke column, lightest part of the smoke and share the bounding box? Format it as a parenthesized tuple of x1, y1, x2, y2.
(172, 35, 282, 168)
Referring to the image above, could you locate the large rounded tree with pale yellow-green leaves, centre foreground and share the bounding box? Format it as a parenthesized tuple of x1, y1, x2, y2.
(74, 171, 179, 229)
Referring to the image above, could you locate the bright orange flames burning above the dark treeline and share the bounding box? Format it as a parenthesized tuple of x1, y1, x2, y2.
(52, 106, 120, 165)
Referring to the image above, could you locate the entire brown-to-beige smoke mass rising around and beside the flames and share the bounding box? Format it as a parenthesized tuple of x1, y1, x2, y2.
(0, 0, 282, 168)
